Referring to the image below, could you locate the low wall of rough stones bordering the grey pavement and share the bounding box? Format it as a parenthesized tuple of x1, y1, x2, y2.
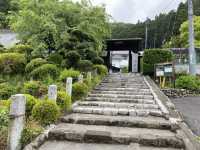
(162, 88, 200, 98)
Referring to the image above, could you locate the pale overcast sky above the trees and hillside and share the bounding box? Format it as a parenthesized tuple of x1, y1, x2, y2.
(74, 0, 185, 23)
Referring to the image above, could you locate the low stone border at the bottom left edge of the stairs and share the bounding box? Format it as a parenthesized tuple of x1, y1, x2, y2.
(23, 125, 55, 150)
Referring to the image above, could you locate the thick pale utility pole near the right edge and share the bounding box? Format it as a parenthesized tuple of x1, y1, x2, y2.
(188, 0, 196, 75)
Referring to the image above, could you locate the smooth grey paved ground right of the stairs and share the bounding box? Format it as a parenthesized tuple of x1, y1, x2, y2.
(172, 97, 200, 136)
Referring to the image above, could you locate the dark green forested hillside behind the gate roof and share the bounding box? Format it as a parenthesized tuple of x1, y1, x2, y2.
(112, 0, 200, 48)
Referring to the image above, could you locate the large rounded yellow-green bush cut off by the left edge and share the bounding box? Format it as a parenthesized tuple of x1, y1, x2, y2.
(0, 53, 26, 75)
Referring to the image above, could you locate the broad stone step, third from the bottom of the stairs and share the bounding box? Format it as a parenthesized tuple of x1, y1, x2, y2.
(61, 114, 179, 131)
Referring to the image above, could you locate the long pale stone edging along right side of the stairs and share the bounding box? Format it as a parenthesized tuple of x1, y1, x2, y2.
(144, 76, 200, 150)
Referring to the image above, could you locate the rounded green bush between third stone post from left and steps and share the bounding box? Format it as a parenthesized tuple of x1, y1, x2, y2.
(72, 83, 88, 101)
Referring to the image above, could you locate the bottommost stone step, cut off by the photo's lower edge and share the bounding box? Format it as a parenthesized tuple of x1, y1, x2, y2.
(39, 141, 181, 150)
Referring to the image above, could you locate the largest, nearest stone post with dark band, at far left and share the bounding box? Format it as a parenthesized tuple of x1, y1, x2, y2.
(8, 94, 26, 150)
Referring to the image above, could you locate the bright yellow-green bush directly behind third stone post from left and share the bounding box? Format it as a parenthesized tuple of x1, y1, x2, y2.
(60, 69, 80, 82)
